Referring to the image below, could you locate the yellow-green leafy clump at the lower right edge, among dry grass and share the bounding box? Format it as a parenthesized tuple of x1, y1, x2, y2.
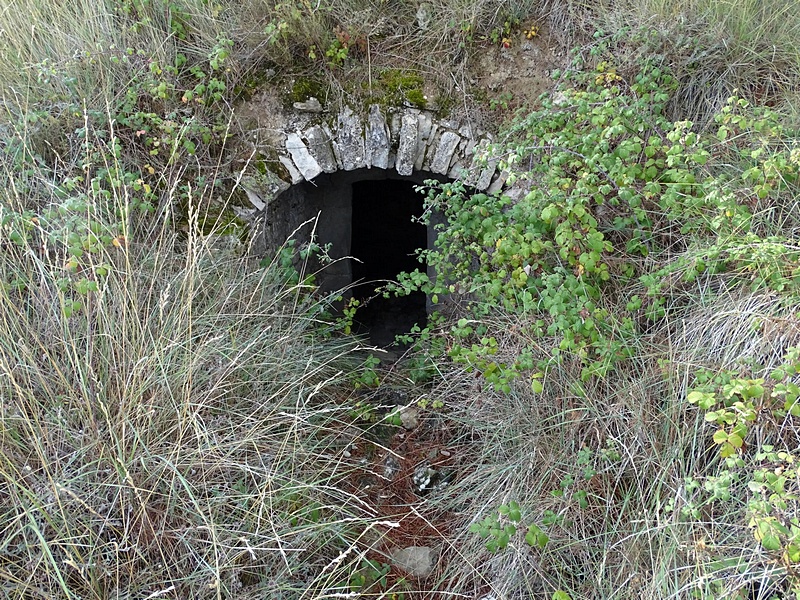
(670, 348, 800, 594)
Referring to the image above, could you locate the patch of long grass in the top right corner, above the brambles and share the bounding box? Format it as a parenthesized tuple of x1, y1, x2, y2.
(590, 0, 800, 122)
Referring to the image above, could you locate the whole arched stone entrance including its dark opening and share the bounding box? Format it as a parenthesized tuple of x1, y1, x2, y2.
(242, 105, 506, 344)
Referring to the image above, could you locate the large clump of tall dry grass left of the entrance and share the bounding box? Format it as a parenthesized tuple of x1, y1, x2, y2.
(0, 127, 388, 599)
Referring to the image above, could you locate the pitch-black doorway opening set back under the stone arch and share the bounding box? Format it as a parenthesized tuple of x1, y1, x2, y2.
(350, 179, 428, 347)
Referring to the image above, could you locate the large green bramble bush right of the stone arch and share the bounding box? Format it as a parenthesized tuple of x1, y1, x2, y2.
(391, 45, 800, 391)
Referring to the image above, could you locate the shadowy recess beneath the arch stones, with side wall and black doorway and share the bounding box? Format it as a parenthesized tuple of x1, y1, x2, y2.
(265, 169, 443, 348)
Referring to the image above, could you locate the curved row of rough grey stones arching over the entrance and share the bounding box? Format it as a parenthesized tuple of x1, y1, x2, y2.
(244, 103, 507, 260)
